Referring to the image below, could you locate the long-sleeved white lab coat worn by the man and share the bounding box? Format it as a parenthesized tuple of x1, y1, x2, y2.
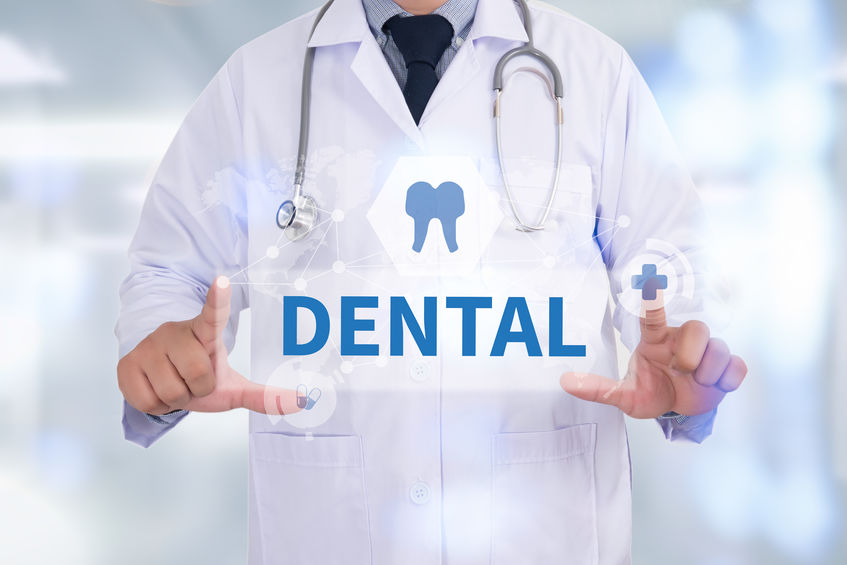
(117, 0, 716, 565)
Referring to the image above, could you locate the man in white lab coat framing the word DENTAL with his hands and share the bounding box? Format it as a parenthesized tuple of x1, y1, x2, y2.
(116, 0, 746, 565)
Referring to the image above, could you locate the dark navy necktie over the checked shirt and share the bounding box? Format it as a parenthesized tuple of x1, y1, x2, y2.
(383, 14, 453, 124)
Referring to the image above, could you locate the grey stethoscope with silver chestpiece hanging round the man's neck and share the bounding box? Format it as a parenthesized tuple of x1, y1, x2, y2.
(276, 0, 564, 241)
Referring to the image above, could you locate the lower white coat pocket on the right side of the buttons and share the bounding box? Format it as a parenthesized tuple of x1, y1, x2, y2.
(491, 424, 598, 565)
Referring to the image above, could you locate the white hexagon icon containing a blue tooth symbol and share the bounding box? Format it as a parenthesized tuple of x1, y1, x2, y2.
(367, 157, 503, 276)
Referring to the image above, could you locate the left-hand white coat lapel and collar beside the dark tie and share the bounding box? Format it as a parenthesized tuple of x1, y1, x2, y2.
(309, 0, 423, 146)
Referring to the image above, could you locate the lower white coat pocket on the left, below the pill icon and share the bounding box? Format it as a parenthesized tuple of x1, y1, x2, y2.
(250, 433, 371, 565)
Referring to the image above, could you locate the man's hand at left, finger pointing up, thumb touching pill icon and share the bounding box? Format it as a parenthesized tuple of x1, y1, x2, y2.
(118, 277, 300, 415)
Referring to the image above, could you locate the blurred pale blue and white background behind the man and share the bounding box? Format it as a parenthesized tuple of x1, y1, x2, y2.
(0, 0, 847, 565)
